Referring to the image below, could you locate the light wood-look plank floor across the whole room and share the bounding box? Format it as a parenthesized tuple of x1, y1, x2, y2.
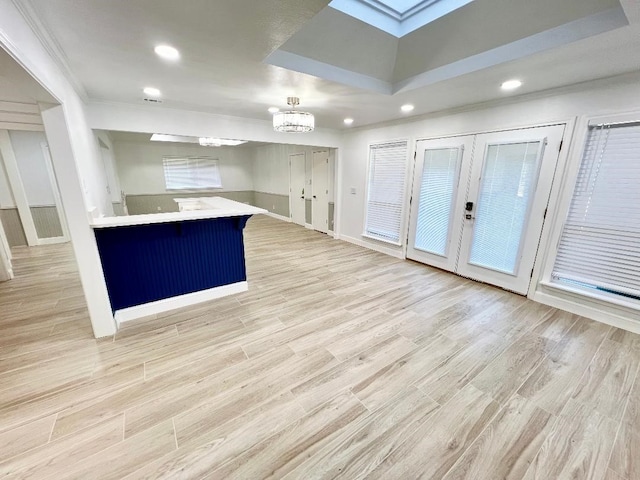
(0, 217, 640, 480)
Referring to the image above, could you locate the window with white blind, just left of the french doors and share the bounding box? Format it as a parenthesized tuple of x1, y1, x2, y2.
(363, 141, 407, 245)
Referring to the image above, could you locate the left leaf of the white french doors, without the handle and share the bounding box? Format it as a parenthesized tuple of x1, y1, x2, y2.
(407, 136, 474, 271)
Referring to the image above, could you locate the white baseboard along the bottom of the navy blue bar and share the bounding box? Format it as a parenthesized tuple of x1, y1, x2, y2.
(113, 282, 249, 326)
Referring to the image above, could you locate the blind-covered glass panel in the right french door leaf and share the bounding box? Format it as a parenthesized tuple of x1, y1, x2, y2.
(469, 141, 542, 275)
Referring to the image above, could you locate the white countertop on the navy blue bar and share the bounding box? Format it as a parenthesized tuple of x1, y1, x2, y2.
(91, 197, 267, 228)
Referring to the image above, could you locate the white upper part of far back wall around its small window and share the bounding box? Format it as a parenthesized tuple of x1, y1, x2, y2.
(114, 141, 254, 195)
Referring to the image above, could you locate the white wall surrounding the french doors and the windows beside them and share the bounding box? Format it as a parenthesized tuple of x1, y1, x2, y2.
(337, 74, 640, 332)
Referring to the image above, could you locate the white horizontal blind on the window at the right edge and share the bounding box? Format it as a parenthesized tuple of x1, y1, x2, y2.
(552, 122, 640, 298)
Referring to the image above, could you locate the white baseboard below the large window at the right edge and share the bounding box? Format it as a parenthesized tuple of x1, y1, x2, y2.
(530, 284, 640, 334)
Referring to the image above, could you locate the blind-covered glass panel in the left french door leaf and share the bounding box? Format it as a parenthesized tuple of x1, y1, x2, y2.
(414, 148, 461, 256)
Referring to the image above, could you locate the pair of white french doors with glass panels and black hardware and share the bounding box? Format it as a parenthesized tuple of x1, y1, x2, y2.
(407, 125, 564, 294)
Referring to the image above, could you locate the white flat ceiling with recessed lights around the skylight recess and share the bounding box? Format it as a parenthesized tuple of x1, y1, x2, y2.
(15, 0, 640, 128)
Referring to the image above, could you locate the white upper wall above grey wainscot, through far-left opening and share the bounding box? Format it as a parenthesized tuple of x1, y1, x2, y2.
(9, 130, 56, 207)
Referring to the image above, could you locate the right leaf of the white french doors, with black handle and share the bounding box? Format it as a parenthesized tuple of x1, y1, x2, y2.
(456, 125, 564, 294)
